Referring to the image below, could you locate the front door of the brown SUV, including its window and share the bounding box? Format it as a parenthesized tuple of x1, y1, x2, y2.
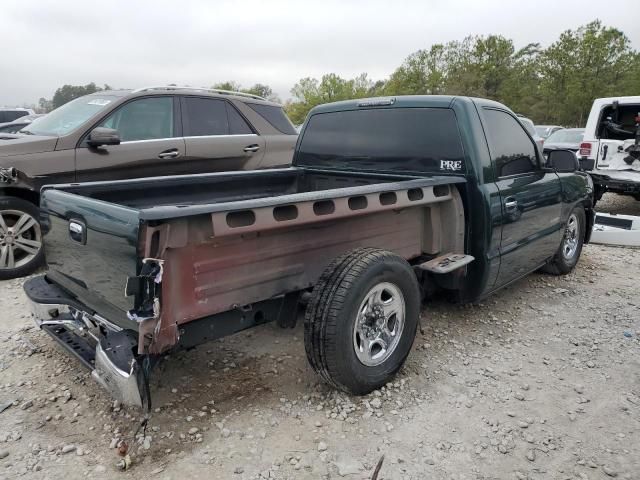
(76, 95, 185, 182)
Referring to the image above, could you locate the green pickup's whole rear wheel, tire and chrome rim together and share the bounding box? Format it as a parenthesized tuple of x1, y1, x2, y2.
(305, 248, 420, 395)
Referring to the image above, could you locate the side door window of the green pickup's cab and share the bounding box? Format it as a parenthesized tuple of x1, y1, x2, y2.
(484, 108, 538, 177)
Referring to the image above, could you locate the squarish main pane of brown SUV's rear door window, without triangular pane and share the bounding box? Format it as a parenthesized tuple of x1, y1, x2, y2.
(184, 97, 229, 137)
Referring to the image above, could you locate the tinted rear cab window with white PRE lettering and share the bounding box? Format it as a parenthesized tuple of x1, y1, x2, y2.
(295, 108, 465, 173)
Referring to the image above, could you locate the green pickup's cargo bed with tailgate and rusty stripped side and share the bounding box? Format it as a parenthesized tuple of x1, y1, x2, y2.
(41, 168, 465, 352)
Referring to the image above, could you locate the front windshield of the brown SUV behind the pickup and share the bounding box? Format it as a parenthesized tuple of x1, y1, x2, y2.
(20, 95, 117, 136)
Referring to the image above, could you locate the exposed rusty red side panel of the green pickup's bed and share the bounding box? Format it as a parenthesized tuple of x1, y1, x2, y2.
(139, 185, 464, 354)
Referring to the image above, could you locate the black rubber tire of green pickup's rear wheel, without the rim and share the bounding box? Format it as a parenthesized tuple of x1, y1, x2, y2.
(304, 248, 420, 395)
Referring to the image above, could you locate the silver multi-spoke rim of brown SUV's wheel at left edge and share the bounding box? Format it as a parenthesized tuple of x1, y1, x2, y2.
(0, 210, 42, 270)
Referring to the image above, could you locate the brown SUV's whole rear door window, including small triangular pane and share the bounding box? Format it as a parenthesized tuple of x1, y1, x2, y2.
(184, 97, 253, 137)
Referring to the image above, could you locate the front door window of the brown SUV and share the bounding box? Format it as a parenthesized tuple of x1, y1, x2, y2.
(100, 97, 174, 142)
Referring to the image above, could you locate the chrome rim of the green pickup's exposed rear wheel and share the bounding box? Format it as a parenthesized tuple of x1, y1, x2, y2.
(353, 282, 405, 367)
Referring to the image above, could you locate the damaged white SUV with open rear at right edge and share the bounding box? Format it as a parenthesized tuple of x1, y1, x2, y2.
(579, 96, 640, 200)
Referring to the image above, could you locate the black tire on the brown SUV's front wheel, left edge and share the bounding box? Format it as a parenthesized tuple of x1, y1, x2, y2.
(0, 197, 44, 280)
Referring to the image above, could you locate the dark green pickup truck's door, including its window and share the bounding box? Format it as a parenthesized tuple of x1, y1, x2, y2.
(482, 107, 562, 286)
